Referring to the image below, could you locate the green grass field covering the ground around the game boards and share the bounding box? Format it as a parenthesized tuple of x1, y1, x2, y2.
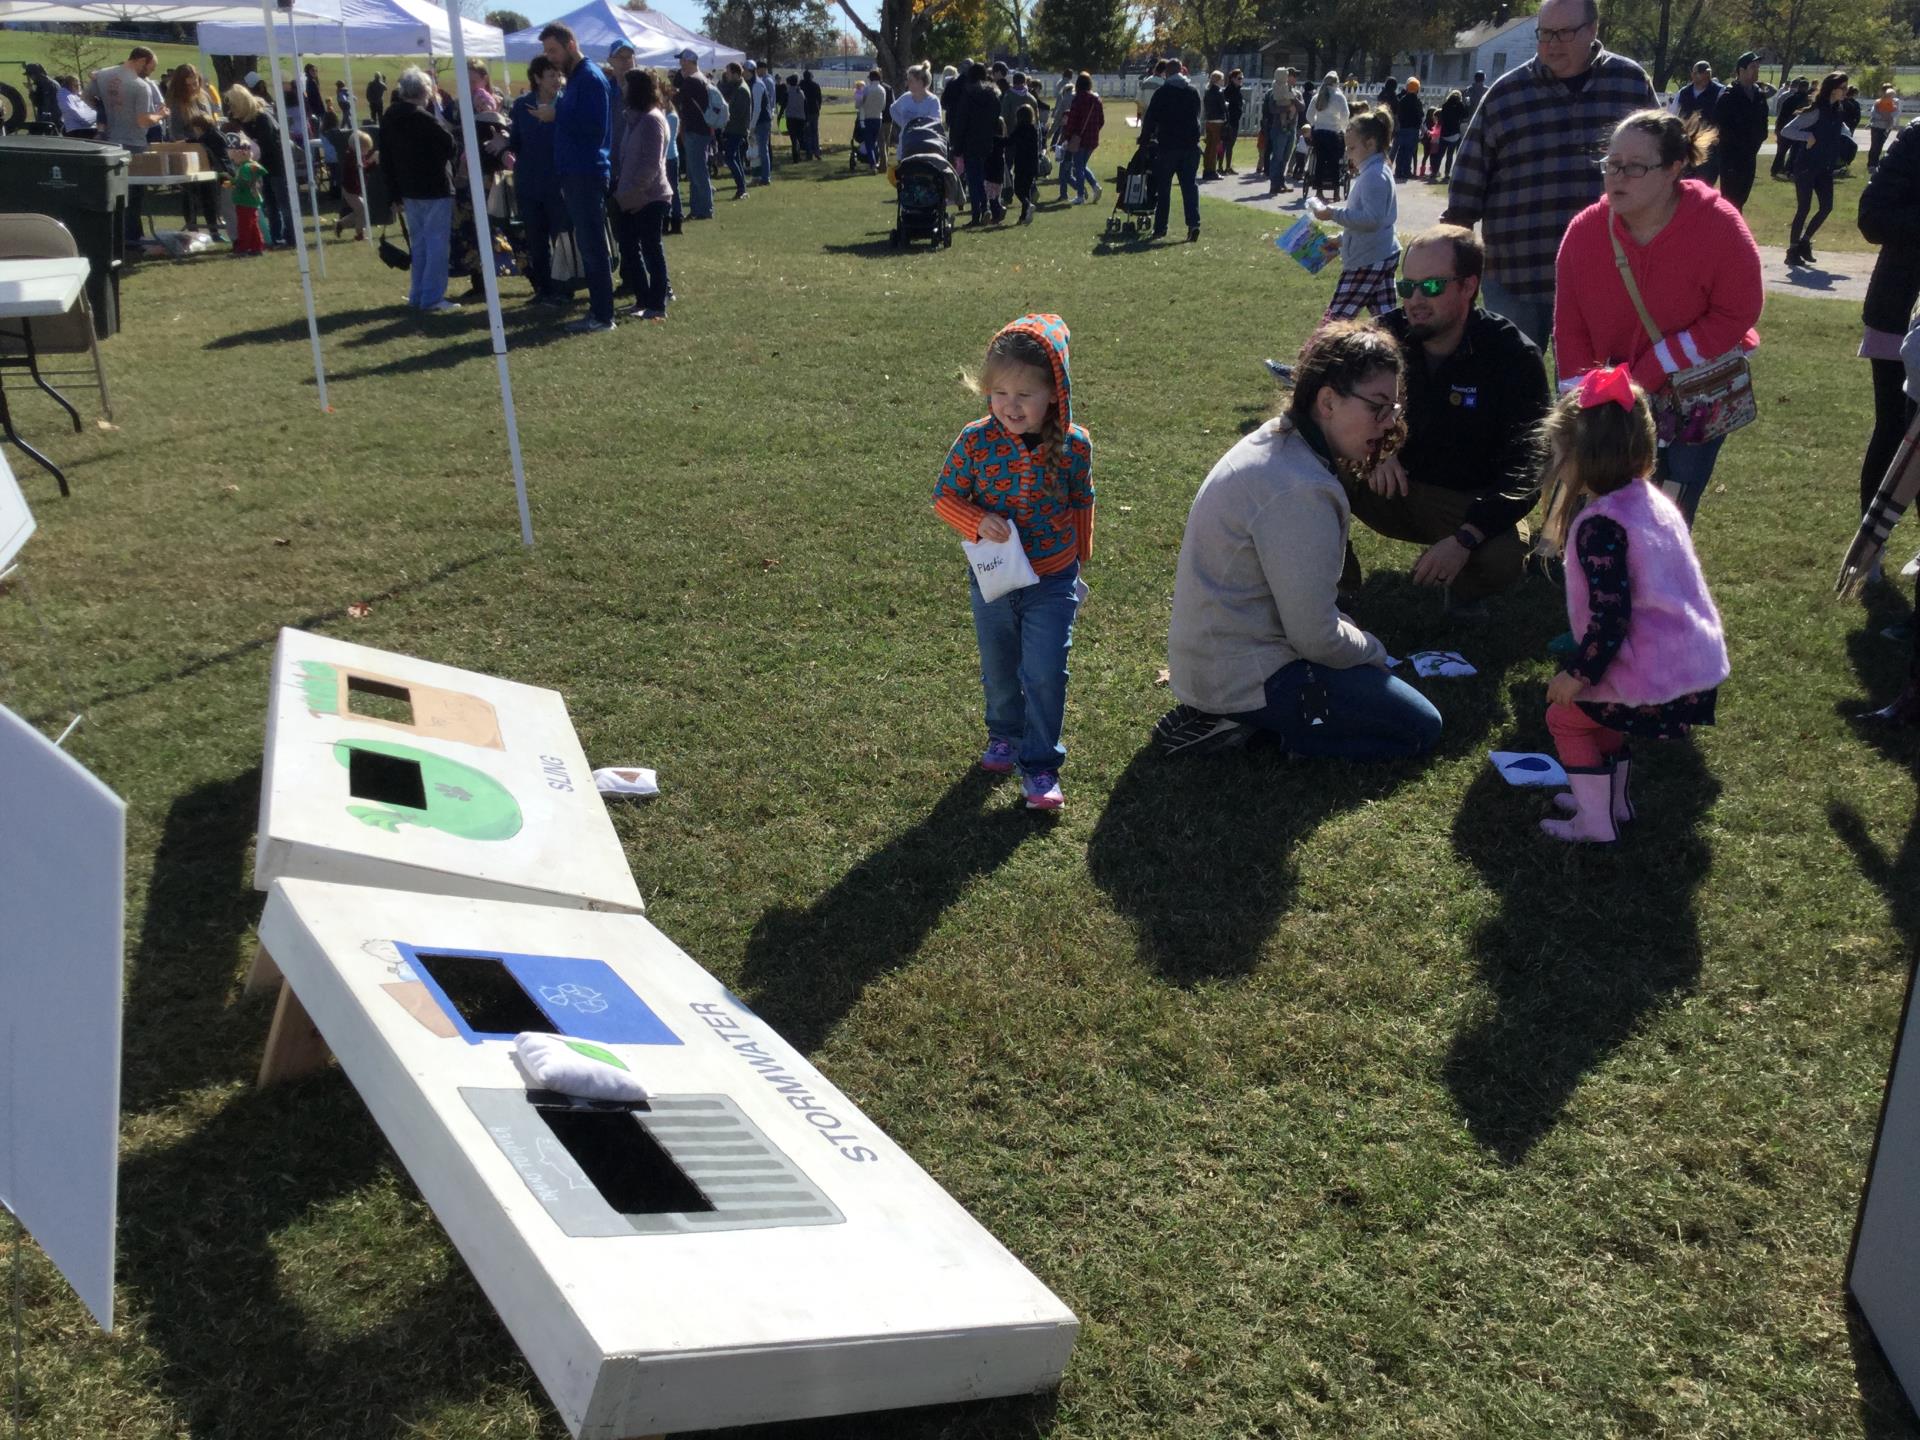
(0, 104, 1920, 1440)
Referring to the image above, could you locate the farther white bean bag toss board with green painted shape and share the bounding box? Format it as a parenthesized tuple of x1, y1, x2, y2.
(253, 630, 643, 910)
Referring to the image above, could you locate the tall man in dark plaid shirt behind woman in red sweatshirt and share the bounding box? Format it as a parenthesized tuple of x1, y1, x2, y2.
(1440, 0, 1659, 349)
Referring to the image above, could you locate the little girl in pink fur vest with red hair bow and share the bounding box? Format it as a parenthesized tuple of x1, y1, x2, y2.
(1540, 365, 1728, 845)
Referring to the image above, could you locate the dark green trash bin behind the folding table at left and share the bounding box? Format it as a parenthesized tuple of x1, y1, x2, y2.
(0, 134, 127, 340)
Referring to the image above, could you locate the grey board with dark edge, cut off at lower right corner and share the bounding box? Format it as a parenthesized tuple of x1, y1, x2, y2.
(1847, 952, 1920, 1407)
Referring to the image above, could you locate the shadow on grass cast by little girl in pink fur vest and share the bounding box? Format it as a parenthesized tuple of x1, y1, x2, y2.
(1444, 685, 1720, 1165)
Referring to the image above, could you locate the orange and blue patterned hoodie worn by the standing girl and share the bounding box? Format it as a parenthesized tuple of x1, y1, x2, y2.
(933, 315, 1092, 574)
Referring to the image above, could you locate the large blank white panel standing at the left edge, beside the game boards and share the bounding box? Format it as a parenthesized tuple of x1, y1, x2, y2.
(0, 707, 127, 1329)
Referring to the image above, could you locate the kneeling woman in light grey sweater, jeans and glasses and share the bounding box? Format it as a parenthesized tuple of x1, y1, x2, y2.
(1156, 323, 1440, 760)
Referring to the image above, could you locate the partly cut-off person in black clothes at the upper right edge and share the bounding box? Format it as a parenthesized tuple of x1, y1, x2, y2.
(1860, 121, 1920, 515)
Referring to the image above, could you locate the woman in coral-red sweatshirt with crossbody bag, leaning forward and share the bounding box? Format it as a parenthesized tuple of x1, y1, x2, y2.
(1553, 109, 1764, 526)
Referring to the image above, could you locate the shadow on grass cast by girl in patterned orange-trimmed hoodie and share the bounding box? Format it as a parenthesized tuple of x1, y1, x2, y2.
(741, 770, 1050, 1054)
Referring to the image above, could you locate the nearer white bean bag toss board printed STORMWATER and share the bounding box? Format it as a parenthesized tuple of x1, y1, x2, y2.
(259, 879, 1079, 1440)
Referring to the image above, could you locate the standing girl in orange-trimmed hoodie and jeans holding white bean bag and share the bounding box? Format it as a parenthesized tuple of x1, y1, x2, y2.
(933, 315, 1092, 810)
